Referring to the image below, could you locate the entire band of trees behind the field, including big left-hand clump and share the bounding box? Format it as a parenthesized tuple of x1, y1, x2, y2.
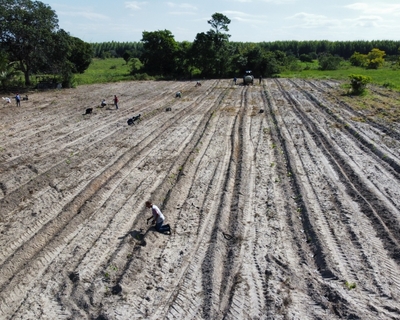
(0, 0, 400, 87)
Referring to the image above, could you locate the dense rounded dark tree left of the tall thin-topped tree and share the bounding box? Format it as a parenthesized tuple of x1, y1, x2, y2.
(141, 30, 178, 76)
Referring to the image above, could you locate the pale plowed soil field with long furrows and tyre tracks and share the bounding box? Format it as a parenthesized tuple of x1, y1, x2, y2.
(0, 79, 400, 320)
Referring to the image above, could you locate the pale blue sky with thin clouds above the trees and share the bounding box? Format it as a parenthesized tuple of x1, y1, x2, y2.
(42, 0, 400, 42)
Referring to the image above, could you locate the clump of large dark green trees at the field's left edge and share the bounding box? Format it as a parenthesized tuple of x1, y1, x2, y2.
(0, 0, 92, 88)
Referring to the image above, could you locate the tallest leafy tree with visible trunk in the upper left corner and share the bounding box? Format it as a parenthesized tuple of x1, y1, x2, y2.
(0, 0, 58, 85)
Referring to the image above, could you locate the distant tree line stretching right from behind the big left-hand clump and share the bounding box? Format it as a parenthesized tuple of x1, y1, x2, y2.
(92, 13, 400, 78)
